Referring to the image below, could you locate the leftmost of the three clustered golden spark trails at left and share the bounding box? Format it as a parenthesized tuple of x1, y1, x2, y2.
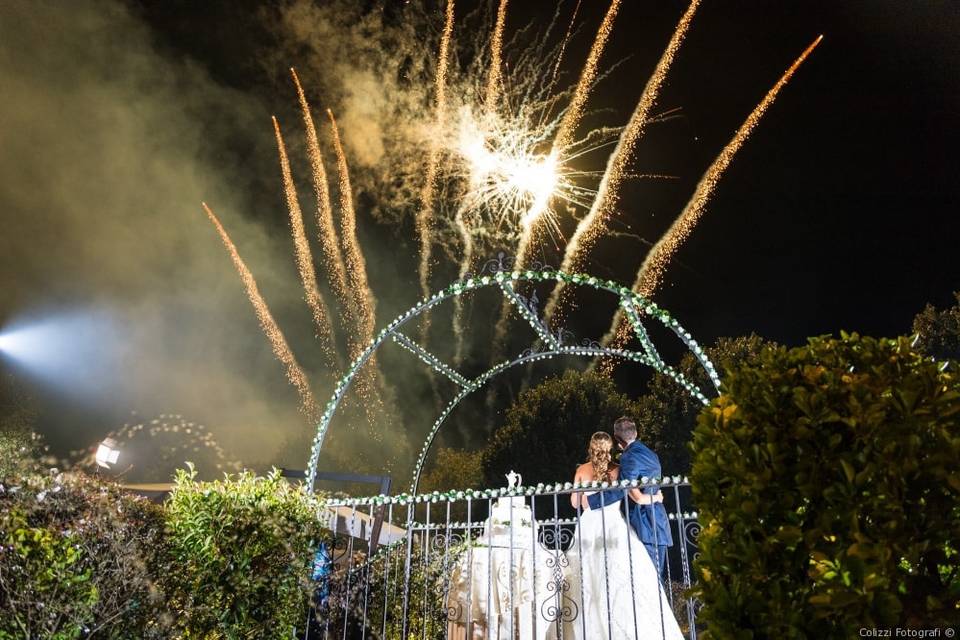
(272, 117, 338, 367)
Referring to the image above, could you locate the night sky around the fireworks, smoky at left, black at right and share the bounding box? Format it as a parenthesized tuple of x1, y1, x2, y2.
(0, 0, 960, 476)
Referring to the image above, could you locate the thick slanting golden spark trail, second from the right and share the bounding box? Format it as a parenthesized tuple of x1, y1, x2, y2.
(544, 0, 700, 328)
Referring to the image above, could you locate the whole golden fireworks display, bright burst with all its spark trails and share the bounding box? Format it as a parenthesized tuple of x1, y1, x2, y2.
(207, 0, 819, 470)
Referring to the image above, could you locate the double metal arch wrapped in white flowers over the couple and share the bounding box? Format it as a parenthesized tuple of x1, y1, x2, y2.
(307, 262, 720, 490)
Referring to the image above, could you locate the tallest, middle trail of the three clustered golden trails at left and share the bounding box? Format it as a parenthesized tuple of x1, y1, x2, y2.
(290, 69, 357, 327)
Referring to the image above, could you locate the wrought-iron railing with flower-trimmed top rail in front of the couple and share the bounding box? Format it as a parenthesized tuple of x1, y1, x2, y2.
(299, 477, 700, 640)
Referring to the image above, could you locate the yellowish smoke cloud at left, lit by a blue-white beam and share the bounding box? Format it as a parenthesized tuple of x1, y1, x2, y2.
(0, 0, 316, 470)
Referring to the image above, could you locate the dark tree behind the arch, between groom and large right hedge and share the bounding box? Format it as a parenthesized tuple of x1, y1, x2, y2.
(634, 334, 768, 475)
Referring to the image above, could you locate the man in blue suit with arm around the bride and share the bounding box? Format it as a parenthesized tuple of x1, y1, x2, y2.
(587, 417, 673, 576)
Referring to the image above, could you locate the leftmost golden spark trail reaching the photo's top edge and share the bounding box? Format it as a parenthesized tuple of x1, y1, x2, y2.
(416, 0, 453, 306)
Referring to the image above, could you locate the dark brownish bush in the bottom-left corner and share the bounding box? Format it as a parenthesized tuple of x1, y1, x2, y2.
(0, 470, 167, 639)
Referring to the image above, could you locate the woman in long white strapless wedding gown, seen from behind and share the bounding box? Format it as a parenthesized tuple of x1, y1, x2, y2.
(564, 431, 683, 640)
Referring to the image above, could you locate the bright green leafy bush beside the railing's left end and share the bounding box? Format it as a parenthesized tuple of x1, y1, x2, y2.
(166, 467, 323, 639)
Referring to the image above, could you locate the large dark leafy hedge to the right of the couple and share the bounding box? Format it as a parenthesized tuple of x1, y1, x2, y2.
(692, 334, 960, 638)
